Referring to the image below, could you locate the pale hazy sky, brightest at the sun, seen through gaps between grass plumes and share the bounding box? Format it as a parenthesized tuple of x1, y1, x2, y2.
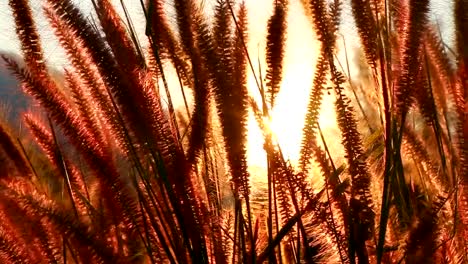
(0, 0, 453, 171)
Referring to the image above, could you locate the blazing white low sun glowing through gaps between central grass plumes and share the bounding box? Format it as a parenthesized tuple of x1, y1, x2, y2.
(247, 70, 342, 186)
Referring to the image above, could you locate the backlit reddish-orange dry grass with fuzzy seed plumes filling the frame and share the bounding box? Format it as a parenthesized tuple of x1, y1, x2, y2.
(0, 0, 468, 264)
